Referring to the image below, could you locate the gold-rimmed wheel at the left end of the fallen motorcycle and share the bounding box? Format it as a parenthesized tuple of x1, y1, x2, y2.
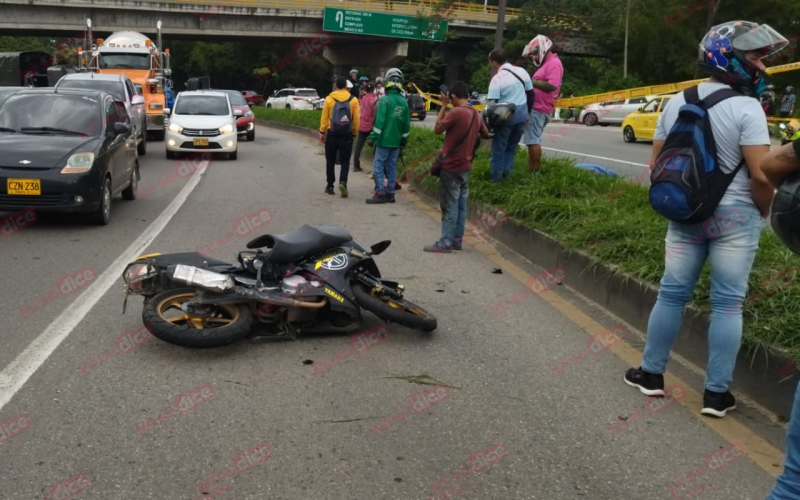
(142, 288, 253, 348)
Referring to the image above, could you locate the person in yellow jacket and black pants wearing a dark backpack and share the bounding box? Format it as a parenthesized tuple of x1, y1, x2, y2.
(319, 76, 360, 198)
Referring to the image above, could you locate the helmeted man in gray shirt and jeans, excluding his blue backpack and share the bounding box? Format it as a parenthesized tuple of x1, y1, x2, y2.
(625, 21, 789, 417)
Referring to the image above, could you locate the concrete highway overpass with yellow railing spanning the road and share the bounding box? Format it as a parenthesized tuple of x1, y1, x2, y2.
(0, 0, 605, 77)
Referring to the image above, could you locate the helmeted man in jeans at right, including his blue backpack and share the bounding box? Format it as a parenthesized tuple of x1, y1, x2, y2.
(624, 21, 789, 417)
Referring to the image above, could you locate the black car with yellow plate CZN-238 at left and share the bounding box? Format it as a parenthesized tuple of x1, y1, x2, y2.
(0, 89, 139, 225)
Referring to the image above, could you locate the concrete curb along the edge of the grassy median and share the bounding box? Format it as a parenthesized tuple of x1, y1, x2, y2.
(259, 121, 796, 418)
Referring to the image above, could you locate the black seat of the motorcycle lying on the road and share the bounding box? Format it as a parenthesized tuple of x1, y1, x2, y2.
(247, 224, 353, 264)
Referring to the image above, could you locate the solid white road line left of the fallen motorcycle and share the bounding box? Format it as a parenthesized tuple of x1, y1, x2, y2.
(0, 162, 208, 411)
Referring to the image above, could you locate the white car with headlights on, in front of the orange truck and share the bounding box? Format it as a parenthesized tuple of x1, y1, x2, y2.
(164, 90, 238, 160)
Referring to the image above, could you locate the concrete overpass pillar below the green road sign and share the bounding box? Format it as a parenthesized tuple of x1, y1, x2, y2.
(322, 40, 408, 80)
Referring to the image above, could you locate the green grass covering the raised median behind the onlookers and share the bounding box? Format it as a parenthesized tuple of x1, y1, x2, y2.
(256, 108, 800, 360)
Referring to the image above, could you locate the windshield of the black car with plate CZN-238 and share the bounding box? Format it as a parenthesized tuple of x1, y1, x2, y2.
(0, 94, 101, 136)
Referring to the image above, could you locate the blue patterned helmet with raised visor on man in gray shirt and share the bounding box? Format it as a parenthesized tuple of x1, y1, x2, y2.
(697, 21, 789, 97)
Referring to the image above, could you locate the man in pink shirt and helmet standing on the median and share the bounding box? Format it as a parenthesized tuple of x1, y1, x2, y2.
(522, 35, 564, 172)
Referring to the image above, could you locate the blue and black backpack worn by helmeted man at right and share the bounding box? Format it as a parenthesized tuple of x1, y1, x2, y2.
(650, 86, 744, 224)
